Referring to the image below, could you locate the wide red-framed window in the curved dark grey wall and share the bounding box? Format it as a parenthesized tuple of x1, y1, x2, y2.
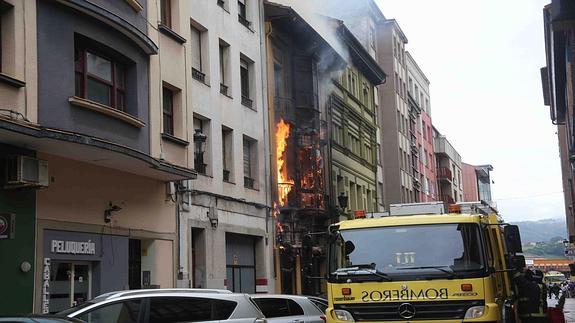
(74, 42, 126, 111)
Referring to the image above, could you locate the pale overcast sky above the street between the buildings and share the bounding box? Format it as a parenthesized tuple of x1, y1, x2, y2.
(376, 0, 565, 221)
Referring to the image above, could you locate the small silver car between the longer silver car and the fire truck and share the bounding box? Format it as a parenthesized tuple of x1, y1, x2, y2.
(252, 295, 325, 323)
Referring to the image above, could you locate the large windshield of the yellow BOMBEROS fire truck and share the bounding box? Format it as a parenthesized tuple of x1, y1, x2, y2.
(330, 223, 485, 278)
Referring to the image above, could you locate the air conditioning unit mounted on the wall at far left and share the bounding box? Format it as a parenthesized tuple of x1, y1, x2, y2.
(4, 155, 49, 188)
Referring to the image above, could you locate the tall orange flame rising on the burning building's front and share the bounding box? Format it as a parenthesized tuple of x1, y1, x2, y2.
(276, 119, 294, 206)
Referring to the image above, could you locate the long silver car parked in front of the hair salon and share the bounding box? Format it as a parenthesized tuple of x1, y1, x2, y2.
(58, 289, 266, 323)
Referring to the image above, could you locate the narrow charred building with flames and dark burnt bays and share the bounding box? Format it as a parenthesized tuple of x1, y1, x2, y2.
(265, 2, 345, 294)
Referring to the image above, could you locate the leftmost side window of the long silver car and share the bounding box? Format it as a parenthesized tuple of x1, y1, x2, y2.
(77, 299, 141, 323)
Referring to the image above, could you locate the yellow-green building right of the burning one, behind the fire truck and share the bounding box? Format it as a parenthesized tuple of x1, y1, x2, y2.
(328, 20, 386, 220)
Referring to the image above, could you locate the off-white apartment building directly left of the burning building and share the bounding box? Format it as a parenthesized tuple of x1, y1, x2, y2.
(183, 0, 273, 293)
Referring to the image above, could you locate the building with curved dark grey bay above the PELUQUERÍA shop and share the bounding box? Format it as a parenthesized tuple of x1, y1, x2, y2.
(0, 0, 202, 314)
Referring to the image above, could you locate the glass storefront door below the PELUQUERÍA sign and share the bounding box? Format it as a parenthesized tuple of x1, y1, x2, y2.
(49, 261, 92, 313)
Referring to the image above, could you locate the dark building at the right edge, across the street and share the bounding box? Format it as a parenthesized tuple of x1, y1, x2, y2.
(541, 0, 575, 243)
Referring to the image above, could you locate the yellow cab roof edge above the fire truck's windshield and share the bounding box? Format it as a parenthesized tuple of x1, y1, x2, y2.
(339, 213, 488, 230)
